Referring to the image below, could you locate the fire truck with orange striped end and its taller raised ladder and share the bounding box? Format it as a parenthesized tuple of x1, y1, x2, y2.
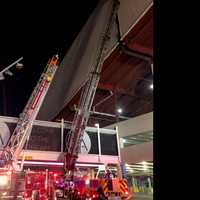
(56, 0, 129, 199)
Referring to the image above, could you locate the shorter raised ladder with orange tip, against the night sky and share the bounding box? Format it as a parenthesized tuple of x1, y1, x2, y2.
(1, 55, 58, 170)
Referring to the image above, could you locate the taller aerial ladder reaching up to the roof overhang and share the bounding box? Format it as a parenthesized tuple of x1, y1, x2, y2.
(64, 0, 119, 178)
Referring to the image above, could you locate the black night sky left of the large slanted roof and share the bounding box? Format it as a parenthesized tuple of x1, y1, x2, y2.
(0, 0, 98, 116)
